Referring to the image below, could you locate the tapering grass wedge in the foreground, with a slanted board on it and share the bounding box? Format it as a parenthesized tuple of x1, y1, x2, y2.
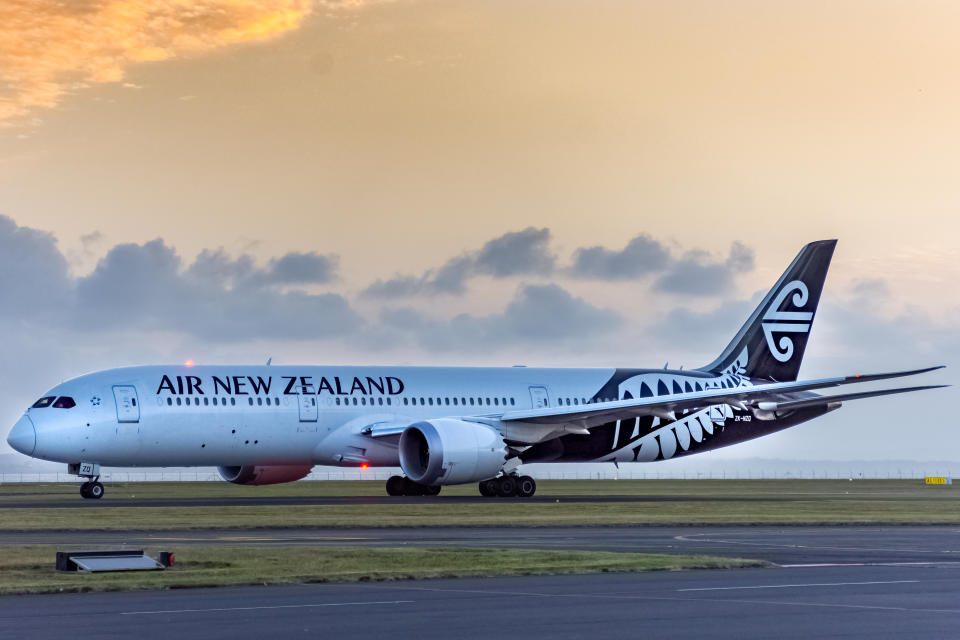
(0, 545, 769, 595)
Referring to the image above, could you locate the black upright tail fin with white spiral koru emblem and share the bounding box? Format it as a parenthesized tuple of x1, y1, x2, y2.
(701, 240, 837, 382)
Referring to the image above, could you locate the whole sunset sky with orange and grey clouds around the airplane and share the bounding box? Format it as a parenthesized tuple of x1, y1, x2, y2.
(0, 0, 960, 460)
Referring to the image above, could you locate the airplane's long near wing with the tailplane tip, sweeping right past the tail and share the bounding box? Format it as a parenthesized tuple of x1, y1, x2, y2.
(500, 366, 944, 428)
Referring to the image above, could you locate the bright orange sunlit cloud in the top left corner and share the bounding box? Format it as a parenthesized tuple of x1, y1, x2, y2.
(0, 0, 314, 124)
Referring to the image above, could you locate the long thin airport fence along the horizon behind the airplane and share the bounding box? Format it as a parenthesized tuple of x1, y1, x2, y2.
(0, 468, 960, 484)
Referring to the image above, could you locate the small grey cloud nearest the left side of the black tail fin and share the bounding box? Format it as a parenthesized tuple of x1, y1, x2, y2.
(654, 242, 754, 296)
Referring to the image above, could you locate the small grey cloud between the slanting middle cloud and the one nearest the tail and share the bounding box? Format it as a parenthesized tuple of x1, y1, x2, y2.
(568, 234, 672, 280)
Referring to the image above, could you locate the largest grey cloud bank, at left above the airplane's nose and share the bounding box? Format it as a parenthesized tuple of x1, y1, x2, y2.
(0, 216, 363, 342)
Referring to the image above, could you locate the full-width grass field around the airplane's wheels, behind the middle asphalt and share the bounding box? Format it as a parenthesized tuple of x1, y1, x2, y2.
(0, 480, 960, 530)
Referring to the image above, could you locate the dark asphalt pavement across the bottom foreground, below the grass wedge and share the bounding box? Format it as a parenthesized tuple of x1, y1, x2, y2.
(0, 565, 960, 640)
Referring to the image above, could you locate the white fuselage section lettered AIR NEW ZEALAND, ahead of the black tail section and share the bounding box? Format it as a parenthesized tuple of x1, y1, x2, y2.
(16, 366, 652, 466)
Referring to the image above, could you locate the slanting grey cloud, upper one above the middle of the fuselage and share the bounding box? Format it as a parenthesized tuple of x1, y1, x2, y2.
(363, 227, 556, 298)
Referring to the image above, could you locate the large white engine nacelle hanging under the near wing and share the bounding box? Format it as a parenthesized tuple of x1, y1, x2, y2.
(400, 418, 507, 485)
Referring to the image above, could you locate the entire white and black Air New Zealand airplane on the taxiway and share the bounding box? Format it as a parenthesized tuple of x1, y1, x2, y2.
(1, 240, 946, 499)
